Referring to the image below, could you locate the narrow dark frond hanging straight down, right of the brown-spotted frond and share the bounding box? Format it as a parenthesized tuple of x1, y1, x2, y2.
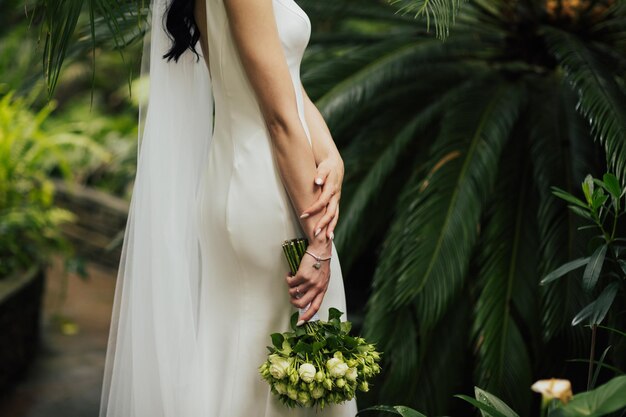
(472, 135, 540, 415)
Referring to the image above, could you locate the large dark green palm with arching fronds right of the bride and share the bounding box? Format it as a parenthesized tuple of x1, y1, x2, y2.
(292, 0, 626, 415)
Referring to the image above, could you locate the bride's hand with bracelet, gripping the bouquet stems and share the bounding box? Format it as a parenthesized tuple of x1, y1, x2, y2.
(285, 246, 330, 326)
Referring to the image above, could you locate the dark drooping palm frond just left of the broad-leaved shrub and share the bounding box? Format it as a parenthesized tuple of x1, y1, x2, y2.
(529, 84, 598, 356)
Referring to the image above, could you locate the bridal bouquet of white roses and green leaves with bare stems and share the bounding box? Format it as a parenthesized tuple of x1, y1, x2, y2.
(259, 239, 380, 409)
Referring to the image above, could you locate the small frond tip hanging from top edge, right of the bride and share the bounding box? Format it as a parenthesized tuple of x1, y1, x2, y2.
(390, 0, 467, 39)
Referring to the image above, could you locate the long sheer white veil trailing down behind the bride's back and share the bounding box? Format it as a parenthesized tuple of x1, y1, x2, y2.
(99, 0, 213, 417)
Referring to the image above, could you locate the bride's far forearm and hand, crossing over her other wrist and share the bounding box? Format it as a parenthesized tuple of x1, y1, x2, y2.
(300, 83, 344, 239)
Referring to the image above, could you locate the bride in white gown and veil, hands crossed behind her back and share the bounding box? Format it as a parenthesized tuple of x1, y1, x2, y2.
(99, 0, 357, 417)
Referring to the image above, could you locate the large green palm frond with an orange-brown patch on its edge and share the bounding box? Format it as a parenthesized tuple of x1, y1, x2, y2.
(370, 77, 524, 332)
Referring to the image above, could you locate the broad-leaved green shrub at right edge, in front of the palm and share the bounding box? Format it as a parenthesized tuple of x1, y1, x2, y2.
(540, 173, 626, 389)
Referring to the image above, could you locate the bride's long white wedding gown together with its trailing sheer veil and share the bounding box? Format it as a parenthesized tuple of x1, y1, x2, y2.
(100, 0, 357, 417)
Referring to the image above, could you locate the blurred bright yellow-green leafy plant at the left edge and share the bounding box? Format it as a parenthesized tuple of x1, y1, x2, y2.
(0, 92, 104, 278)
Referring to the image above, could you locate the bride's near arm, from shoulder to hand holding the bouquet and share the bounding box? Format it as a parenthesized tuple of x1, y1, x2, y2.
(223, 0, 332, 323)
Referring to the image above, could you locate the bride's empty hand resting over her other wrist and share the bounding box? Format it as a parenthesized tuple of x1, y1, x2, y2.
(300, 154, 344, 239)
